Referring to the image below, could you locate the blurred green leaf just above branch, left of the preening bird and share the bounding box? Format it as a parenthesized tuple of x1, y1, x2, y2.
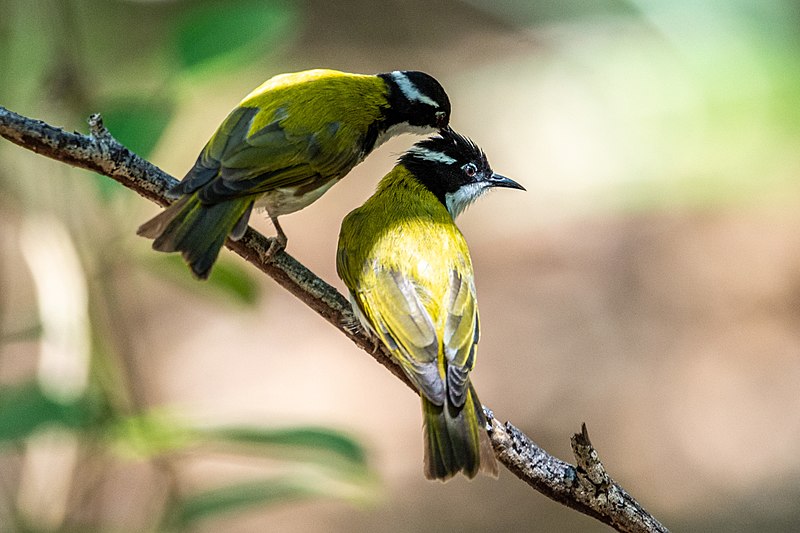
(99, 96, 175, 159)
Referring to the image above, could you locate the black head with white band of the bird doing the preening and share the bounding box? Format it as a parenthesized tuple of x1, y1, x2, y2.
(378, 70, 450, 133)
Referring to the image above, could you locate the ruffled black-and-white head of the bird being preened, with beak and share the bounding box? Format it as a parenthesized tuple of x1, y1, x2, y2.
(400, 127, 525, 218)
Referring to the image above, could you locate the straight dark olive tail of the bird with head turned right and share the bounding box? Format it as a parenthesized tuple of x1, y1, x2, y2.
(422, 384, 497, 481)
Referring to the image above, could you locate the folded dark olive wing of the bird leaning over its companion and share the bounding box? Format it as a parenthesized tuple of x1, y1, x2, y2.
(171, 107, 357, 204)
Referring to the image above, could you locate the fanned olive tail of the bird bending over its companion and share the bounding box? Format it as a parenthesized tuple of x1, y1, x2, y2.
(136, 194, 253, 279)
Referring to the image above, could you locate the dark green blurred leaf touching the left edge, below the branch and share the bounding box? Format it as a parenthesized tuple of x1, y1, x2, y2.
(0, 383, 101, 443)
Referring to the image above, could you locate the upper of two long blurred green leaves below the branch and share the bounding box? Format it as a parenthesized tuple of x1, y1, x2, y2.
(205, 427, 367, 466)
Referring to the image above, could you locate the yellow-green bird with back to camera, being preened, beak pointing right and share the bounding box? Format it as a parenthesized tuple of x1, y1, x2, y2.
(336, 128, 524, 480)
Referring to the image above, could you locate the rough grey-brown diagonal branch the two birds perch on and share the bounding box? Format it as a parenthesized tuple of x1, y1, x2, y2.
(0, 107, 667, 532)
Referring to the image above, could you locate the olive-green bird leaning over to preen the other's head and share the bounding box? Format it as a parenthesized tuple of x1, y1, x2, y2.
(138, 69, 450, 279)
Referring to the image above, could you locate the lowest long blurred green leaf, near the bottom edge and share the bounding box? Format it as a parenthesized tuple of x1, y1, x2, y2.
(177, 478, 329, 527)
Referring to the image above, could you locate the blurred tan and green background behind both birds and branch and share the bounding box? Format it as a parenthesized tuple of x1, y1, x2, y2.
(0, 0, 800, 532)
